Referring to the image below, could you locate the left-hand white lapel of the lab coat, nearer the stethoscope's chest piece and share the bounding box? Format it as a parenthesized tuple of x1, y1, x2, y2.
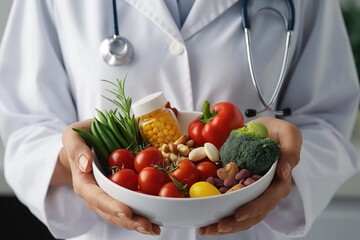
(125, 0, 183, 42)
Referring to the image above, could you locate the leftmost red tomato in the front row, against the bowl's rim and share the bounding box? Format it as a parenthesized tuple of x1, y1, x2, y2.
(109, 168, 139, 191)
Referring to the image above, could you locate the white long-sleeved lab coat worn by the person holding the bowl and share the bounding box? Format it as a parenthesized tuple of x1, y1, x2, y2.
(0, 0, 359, 240)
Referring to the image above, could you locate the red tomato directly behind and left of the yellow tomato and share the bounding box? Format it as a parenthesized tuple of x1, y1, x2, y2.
(170, 159, 200, 189)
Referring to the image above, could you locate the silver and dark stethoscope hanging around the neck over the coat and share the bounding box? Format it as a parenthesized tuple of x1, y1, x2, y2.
(100, 0, 295, 117)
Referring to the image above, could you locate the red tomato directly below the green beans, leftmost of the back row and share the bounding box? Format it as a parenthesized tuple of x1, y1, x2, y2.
(108, 148, 135, 170)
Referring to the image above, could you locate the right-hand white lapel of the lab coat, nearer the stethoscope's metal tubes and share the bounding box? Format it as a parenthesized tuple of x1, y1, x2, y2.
(181, 0, 240, 40)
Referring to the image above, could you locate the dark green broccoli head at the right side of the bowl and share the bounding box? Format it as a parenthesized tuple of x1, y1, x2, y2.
(220, 125, 280, 175)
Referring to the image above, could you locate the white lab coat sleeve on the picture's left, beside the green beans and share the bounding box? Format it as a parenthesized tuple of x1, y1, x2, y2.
(0, 1, 96, 238)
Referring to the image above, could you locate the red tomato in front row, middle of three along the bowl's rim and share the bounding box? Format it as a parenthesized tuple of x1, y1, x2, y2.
(138, 167, 171, 195)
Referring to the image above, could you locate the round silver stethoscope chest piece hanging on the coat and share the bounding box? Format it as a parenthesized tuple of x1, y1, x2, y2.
(100, 35, 133, 66)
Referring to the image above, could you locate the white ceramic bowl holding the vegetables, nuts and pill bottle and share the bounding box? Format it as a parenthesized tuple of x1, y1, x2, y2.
(93, 112, 277, 228)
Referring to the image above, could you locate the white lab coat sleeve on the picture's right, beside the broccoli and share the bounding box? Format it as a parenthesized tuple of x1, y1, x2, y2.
(264, 0, 359, 237)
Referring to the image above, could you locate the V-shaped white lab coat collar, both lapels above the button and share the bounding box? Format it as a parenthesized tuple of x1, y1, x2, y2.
(126, 0, 240, 42)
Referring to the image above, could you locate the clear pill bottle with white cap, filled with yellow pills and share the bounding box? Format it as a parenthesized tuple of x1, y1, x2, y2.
(131, 92, 182, 148)
